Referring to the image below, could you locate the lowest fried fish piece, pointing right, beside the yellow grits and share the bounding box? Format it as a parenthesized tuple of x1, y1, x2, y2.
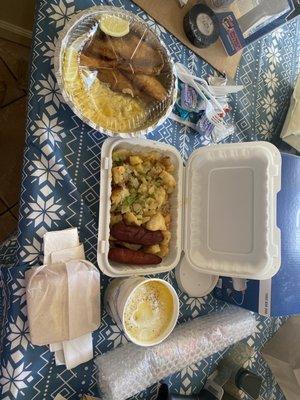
(126, 74, 167, 101)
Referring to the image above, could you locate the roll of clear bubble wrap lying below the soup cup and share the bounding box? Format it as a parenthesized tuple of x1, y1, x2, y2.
(95, 307, 256, 400)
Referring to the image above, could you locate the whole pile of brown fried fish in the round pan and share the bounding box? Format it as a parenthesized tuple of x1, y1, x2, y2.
(80, 33, 167, 103)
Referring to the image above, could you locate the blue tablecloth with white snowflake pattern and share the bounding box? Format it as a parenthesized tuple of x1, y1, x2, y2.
(0, 0, 300, 400)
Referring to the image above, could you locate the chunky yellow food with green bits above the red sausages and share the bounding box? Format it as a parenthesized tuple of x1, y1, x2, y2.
(111, 149, 176, 257)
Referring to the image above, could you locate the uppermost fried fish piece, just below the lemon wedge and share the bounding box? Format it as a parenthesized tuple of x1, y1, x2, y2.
(87, 34, 164, 75)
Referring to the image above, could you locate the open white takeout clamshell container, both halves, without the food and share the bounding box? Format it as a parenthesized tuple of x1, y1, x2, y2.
(97, 139, 281, 279)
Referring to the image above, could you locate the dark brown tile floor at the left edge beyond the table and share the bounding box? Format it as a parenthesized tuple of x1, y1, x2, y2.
(0, 38, 30, 242)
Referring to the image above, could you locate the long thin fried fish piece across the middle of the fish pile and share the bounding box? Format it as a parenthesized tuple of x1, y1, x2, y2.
(80, 53, 158, 75)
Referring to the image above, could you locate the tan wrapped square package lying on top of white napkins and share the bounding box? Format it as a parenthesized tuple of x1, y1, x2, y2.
(25, 260, 100, 346)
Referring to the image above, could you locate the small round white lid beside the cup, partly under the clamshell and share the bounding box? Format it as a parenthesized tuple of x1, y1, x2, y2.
(175, 257, 219, 297)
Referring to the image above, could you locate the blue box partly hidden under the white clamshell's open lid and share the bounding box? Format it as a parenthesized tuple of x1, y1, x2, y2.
(214, 153, 300, 316)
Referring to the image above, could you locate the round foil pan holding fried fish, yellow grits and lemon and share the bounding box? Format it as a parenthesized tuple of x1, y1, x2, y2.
(55, 6, 176, 136)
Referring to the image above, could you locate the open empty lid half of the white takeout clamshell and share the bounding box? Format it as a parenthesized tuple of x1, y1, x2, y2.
(183, 142, 281, 279)
